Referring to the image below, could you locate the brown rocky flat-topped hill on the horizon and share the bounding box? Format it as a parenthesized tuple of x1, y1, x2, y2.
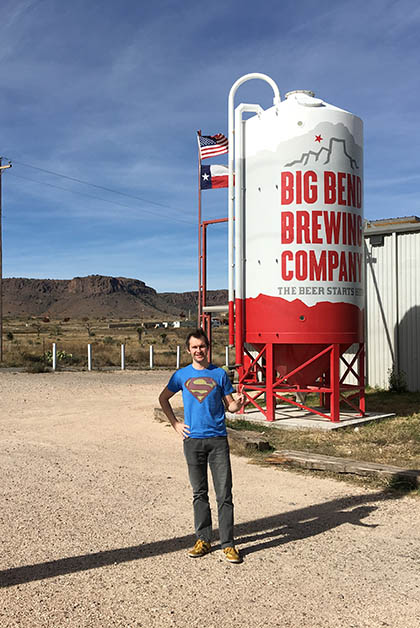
(3, 275, 227, 318)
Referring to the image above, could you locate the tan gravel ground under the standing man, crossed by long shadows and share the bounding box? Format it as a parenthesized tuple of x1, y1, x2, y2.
(0, 371, 420, 628)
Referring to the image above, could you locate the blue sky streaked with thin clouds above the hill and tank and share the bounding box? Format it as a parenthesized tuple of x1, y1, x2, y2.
(0, 0, 420, 291)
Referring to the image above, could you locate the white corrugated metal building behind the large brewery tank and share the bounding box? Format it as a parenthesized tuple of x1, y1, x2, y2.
(365, 216, 420, 391)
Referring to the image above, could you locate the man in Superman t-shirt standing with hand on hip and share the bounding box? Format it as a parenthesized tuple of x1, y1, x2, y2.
(159, 329, 245, 563)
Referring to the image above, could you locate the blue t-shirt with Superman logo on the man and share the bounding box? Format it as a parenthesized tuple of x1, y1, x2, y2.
(168, 364, 235, 438)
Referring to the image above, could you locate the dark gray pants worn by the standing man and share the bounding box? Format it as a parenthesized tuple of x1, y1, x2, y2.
(184, 436, 234, 548)
